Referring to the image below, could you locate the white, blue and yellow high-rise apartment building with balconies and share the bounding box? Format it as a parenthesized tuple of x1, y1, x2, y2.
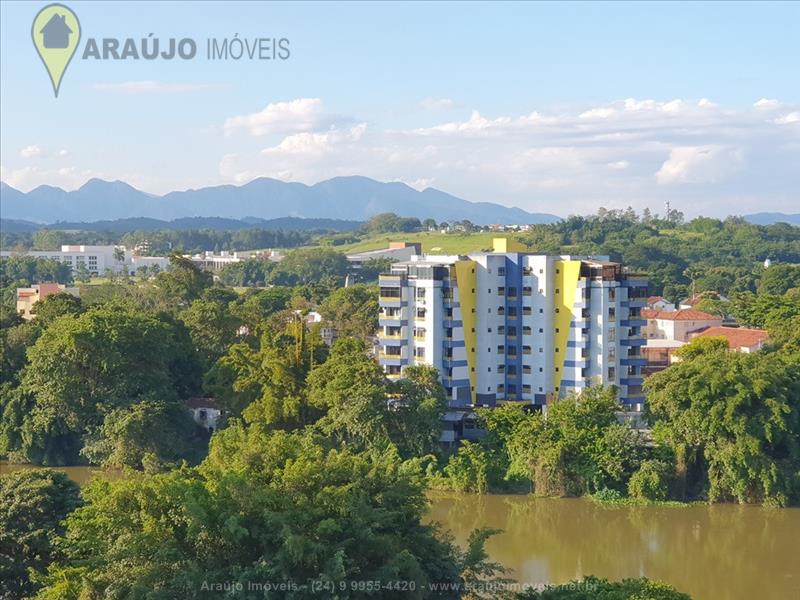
(379, 239, 647, 410)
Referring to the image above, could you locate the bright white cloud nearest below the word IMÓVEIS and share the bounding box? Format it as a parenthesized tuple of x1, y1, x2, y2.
(225, 98, 323, 135)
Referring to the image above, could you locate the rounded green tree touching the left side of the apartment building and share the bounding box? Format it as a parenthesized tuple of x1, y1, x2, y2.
(319, 284, 378, 339)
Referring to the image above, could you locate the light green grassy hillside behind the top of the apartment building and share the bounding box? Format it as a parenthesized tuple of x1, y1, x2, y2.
(316, 231, 518, 254)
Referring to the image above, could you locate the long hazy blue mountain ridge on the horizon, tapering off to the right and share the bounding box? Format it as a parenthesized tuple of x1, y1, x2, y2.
(0, 176, 560, 225)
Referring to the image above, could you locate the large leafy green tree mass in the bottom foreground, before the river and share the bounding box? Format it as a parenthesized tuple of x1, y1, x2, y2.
(34, 424, 466, 599)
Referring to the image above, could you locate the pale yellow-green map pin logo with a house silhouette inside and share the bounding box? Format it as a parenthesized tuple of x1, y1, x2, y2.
(31, 4, 81, 98)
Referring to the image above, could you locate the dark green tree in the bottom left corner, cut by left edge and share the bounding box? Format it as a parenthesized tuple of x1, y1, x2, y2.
(0, 469, 80, 598)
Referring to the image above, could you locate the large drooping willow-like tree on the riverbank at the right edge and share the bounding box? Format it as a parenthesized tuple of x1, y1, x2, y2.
(645, 348, 800, 505)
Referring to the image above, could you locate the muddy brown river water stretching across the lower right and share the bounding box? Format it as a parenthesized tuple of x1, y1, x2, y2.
(430, 493, 800, 600)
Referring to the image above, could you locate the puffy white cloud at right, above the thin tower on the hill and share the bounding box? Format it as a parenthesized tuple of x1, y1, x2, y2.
(656, 146, 742, 185)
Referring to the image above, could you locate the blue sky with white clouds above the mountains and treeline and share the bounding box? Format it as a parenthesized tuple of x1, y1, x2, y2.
(0, 0, 800, 216)
